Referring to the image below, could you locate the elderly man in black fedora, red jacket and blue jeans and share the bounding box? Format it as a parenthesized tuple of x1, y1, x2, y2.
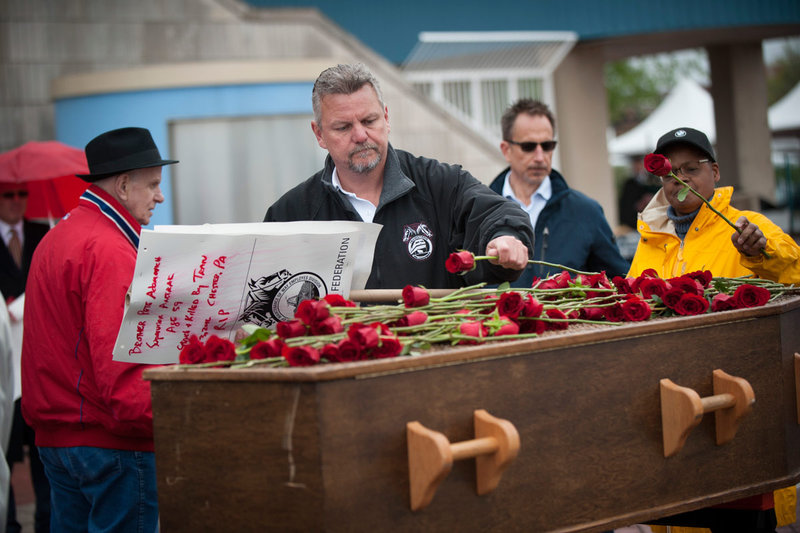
(22, 128, 177, 532)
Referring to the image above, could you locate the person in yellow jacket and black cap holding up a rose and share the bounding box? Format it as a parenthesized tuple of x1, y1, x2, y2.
(630, 127, 800, 283)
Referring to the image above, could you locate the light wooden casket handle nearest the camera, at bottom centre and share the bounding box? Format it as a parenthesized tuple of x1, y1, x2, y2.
(406, 409, 519, 511)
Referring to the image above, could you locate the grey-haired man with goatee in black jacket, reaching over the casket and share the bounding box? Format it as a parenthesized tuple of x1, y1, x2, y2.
(264, 64, 532, 288)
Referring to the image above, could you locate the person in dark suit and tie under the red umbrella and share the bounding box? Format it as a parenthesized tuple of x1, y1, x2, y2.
(0, 183, 50, 533)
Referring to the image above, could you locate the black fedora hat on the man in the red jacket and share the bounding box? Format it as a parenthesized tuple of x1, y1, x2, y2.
(76, 128, 177, 183)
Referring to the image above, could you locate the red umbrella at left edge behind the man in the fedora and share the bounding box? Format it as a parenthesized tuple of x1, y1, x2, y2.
(0, 141, 89, 220)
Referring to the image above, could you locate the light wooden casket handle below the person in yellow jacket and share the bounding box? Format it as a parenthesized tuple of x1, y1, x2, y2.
(661, 369, 756, 457)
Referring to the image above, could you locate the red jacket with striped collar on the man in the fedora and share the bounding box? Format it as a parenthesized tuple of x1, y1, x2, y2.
(22, 186, 153, 451)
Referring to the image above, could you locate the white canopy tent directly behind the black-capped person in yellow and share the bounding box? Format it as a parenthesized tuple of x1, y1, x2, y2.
(608, 78, 717, 159)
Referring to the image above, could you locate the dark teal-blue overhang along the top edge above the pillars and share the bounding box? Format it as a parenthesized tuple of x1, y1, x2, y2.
(244, 0, 800, 64)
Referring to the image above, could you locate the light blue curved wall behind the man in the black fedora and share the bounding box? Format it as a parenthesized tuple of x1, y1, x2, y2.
(55, 83, 313, 225)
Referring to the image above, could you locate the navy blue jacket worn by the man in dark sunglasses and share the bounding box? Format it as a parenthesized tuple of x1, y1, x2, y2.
(489, 168, 630, 287)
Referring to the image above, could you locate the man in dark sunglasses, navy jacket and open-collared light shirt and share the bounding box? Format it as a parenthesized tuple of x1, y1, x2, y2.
(490, 98, 628, 287)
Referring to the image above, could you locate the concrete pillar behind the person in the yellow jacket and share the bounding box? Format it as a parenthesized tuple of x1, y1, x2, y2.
(707, 42, 775, 209)
